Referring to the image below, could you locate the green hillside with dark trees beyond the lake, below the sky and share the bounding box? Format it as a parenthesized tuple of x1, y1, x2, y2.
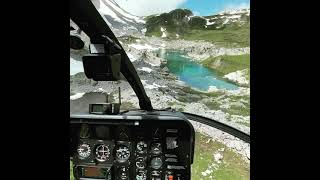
(145, 9, 250, 47)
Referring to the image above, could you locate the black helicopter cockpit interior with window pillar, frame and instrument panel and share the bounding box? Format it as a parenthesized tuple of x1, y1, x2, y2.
(70, 0, 250, 180)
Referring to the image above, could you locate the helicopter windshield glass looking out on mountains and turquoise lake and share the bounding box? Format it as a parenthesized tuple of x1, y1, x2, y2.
(70, 0, 250, 180)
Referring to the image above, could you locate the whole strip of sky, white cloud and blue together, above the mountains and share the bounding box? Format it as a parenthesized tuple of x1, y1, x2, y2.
(114, 0, 250, 16)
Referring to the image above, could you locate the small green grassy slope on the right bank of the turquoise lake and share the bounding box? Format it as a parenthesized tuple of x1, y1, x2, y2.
(201, 54, 250, 75)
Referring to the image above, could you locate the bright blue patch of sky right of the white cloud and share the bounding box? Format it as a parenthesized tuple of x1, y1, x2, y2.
(180, 0, 250, 16)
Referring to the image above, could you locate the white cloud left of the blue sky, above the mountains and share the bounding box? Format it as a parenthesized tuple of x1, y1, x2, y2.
(114, 0, 187, 16)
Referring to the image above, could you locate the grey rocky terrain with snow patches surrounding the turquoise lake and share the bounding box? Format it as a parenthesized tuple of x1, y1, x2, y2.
(70, 33, 250, 157)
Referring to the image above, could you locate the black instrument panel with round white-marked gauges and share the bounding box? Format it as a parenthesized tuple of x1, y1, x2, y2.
(70, 112, 194, 180)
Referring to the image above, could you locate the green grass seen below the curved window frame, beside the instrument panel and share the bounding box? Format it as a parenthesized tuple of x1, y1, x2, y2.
(191, 132, 250, 180)
